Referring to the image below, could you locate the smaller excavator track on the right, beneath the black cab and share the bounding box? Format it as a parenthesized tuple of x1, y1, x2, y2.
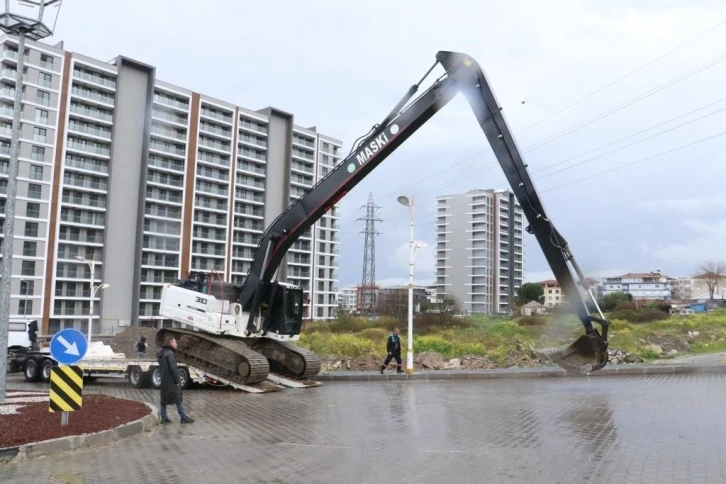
(249, 338, 322, 380)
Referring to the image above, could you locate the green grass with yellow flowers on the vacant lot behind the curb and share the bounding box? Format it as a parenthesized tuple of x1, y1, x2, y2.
(300, 308, 726, 364)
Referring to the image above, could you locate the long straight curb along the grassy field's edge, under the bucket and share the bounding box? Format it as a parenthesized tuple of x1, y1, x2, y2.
(312, 363, 726, 382)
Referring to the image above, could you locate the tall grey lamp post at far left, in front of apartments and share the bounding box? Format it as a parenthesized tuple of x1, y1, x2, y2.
(0, 0, 61, 403)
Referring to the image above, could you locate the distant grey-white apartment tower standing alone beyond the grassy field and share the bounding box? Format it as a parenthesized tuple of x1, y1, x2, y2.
(436, 189, 525, 314)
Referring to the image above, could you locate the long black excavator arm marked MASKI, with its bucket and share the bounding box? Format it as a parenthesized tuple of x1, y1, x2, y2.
(240, 51, 609, 373)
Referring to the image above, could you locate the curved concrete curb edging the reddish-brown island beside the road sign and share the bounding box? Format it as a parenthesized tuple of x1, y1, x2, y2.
(0, 397, 159, 464)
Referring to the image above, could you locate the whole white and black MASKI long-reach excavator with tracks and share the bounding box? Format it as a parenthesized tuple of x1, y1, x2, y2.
(156, 51, 610, 384)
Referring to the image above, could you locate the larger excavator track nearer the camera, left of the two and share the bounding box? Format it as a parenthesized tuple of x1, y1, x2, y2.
(156, 328, 270, 385)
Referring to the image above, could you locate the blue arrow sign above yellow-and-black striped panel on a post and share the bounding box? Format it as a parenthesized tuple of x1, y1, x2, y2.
(48, 328, 88, 425)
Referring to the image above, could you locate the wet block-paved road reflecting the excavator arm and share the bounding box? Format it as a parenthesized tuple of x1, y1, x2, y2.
(0, 374, 726, 484)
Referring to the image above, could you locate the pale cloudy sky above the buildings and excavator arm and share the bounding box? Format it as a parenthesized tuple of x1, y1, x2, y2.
(37, 0, 726, 287)
